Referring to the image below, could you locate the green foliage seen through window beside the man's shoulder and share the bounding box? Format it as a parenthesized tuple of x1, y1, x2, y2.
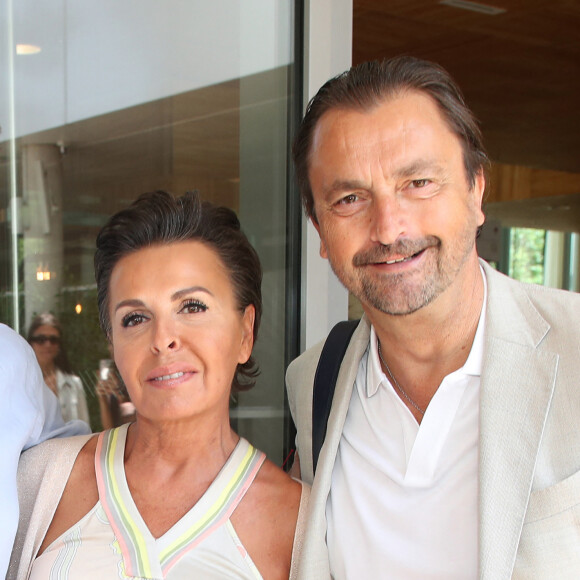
(509, 228, 546, 284)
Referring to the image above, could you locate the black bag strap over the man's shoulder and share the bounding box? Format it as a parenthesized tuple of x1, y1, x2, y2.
(312, 320, 360, 472)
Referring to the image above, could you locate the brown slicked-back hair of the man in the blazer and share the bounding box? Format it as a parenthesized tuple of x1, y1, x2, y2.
(292, 56, 489, 221)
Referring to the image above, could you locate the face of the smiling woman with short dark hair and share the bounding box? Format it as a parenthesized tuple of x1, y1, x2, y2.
(109, 241, 254, 421)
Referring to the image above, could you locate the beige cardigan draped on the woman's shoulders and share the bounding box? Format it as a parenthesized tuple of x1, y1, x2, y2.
(6, 435, 310, 580)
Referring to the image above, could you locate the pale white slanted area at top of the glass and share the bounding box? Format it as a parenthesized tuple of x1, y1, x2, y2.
(0, 0, 293, 140)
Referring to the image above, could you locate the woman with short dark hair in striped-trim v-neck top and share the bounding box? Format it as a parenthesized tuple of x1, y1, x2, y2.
(9, 192, 307, 580)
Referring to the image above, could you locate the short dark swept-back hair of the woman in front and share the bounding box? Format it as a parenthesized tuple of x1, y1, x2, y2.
(95, 191, 262, 391)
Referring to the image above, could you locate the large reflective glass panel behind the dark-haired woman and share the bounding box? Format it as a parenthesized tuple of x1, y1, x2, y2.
(0, 0, 298, 463)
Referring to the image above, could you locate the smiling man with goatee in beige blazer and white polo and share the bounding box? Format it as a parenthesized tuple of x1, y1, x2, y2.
(287, 57, 580, 580)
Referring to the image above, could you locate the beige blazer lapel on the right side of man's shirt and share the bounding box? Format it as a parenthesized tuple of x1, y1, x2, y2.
(479, 267, 558, 580)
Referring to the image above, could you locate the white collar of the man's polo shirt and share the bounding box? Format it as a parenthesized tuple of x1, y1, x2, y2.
(366, 266, 487, 398)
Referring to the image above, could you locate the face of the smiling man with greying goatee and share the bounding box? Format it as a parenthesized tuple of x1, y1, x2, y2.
(309, 92, 485, 314)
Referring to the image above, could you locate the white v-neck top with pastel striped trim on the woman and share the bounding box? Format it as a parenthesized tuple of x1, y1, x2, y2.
(30, 425, 265, 580)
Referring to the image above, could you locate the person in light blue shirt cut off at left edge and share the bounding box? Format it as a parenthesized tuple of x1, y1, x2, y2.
(0, 324, 89, 578)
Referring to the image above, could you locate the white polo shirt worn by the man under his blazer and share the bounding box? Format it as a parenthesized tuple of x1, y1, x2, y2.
(326, 274, 487, 580)
